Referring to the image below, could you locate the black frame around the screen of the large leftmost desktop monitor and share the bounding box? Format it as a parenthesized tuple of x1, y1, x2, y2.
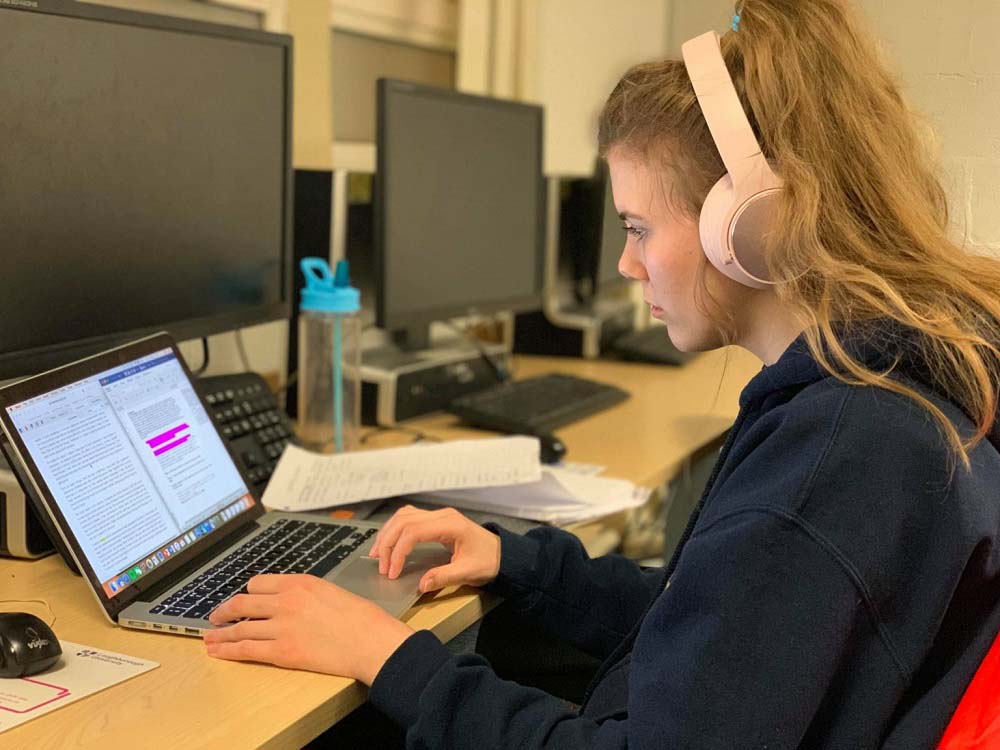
(0, 0, 294, 380)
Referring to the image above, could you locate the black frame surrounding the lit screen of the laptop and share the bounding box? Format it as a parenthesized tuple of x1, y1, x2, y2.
(0, 332, 265, 621)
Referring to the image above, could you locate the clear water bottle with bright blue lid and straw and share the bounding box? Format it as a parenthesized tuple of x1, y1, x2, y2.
(298, 258, 361, 453)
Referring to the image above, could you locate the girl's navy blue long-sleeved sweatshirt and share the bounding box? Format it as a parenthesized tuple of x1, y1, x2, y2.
(370, 329, 1000, 750)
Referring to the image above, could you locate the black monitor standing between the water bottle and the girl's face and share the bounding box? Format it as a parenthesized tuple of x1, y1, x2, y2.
(375, 79, 545, 348)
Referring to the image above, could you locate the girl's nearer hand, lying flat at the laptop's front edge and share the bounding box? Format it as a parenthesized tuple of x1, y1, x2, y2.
(204, 574, 413, 685)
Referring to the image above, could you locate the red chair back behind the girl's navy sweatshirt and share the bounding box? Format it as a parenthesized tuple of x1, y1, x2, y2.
(938, 636, 1000, 750)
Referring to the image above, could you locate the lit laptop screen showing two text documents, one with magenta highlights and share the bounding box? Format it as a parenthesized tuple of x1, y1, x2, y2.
(7, 348, 254, 598)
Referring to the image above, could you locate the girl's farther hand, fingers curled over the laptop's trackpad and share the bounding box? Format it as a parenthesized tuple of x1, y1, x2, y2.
(369, 505, 500, 593)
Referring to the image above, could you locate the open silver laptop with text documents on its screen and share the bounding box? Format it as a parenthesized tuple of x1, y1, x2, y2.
(0, 334, 448, 636)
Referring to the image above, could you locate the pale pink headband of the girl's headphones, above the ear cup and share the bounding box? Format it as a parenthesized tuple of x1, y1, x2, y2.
(681, 31, 771, 190)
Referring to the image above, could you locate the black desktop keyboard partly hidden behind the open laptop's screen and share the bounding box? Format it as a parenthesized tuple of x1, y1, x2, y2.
(197, 372, 299, 497)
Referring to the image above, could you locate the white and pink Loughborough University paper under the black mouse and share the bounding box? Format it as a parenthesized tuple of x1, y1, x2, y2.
(0, 641, 160, 732)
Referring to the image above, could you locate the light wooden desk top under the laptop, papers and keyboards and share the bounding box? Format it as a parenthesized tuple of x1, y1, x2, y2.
(0, 350, 760, 750)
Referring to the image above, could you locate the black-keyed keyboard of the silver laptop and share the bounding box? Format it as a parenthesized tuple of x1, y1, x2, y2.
(150, 518, 377, 619)
